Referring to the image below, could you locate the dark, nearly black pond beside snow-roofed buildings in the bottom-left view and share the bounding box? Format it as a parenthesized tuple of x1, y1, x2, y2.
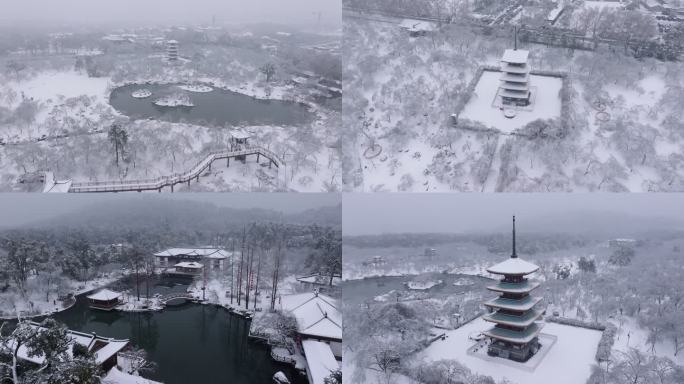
(48, 280, 306, 384)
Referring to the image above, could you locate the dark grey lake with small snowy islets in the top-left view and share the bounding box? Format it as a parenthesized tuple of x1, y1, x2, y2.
(109, 84, 313, 127)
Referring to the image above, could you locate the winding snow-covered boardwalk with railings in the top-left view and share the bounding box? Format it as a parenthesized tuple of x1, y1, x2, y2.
(69, 146, 285, 193)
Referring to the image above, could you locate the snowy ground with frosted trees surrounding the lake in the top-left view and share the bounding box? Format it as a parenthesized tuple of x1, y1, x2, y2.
(0, 41, 341, 192)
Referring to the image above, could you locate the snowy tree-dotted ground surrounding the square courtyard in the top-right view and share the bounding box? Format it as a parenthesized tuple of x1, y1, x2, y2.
(343, 12, 684, 192)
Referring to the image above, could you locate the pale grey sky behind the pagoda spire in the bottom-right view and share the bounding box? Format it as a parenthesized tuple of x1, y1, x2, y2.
(342, 193, 684, 235)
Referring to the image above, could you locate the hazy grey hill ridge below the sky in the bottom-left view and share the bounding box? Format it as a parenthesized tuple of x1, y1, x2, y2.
(26, 198, 341, 231)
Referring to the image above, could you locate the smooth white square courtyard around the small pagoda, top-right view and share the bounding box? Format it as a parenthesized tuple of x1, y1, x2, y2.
(459, 71, 563, 133)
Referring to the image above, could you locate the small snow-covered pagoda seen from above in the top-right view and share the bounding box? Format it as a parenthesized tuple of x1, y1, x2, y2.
(499, 48, 530, 107)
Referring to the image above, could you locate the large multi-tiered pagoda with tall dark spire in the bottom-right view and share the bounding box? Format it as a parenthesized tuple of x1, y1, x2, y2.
(482, 216, 542, 362)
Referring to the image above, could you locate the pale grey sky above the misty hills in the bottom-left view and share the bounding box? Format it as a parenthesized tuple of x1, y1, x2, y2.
(0, 193, 340, 227)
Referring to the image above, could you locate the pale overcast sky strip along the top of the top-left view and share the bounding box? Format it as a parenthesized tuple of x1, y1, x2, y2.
(0, 0, 342, 25)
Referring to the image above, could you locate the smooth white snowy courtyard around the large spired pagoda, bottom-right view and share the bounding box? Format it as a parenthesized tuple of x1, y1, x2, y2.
(416, 318, 601, 384)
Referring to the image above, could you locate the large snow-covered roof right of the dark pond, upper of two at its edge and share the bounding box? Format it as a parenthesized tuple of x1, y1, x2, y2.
(280, 293, 342, 340)
